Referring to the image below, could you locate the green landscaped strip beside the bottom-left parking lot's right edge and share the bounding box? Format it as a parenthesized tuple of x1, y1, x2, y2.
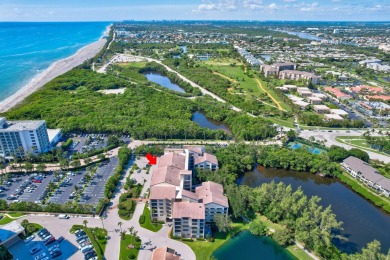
(69, 225, 107, 260)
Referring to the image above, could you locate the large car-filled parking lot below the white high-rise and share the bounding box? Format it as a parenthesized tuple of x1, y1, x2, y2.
(0, 157, 118, 205)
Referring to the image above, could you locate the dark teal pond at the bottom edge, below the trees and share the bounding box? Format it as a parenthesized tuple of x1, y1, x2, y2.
(212, 230, 295, 260)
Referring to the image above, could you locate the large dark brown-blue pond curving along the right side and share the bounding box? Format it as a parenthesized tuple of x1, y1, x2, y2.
(238, 166, 390, 253)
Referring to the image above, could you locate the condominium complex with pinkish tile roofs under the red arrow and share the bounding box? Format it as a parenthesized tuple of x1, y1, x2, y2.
(149, 147, 229, 238)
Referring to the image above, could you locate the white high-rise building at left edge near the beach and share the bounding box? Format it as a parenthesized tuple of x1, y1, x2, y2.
(0, 117, 50, 157)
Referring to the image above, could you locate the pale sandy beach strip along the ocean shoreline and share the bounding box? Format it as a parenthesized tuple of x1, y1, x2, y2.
(0, 26, 111, 112)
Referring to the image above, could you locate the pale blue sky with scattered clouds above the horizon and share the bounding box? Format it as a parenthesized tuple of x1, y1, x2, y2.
(0, 0, 390, 21)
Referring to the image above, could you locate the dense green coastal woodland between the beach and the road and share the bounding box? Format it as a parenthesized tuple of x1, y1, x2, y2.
(3, 67, 276, 140)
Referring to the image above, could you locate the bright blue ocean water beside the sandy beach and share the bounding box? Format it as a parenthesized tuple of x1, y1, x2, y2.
(0, 22, 110, 100)
